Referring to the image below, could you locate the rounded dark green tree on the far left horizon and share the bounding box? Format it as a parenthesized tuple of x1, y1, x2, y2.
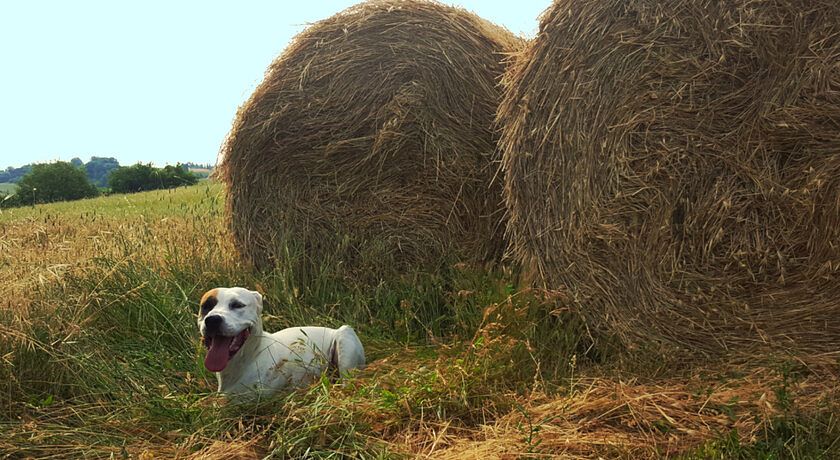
(17, 161, 99, 205)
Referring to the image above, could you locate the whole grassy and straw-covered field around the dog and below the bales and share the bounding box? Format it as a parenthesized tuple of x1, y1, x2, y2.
(0, 182, 840, 459)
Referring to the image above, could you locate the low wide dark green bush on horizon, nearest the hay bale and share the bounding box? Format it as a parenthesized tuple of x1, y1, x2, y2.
(108, 163, 198, 193)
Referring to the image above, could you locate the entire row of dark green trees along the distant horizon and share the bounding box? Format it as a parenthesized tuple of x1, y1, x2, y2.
(0, 157, 199, 207)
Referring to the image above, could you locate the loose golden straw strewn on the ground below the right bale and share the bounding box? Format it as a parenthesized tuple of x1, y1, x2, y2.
(433, 362, 837, 459)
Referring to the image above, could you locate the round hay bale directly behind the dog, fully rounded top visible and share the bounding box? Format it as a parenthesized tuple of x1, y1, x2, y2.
(220, 0, 520, 277)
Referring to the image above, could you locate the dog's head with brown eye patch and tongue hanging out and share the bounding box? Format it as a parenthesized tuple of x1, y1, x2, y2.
(198, 287, 262, 372)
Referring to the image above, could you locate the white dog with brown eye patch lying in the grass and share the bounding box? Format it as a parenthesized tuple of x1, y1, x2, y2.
(198, 287, 365, 396)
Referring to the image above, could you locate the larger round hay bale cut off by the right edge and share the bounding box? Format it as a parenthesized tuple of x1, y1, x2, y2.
(499, 0, 840, 354)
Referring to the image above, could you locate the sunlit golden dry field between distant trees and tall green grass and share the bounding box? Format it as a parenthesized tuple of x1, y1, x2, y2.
(0, 184, 235, 318)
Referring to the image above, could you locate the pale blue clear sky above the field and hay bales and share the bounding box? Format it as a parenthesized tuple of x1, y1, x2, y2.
(0, 0, 551, 169)
